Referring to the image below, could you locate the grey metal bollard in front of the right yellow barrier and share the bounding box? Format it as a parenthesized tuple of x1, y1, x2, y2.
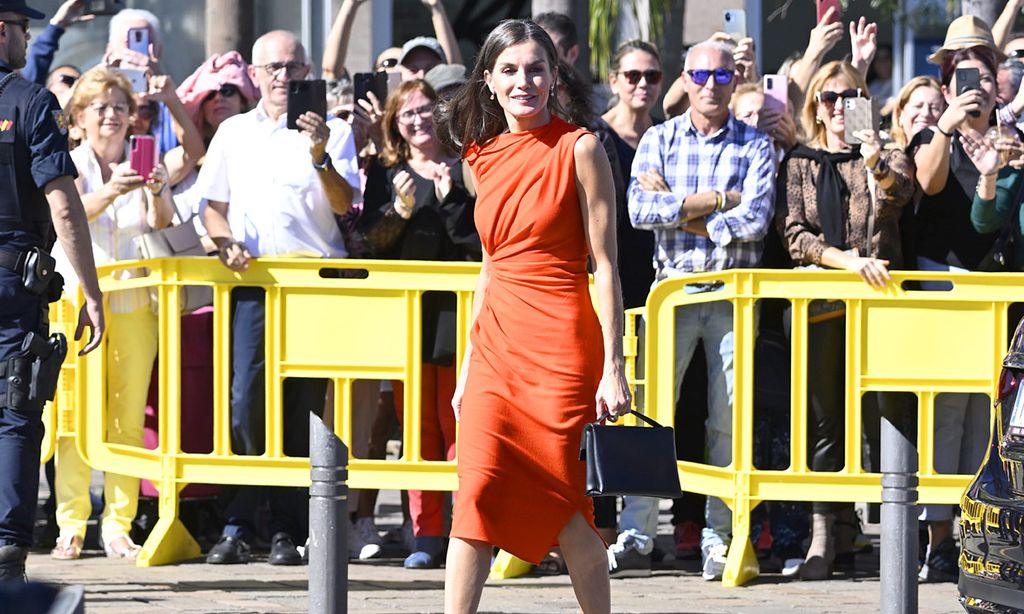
(879, 394, 918, 614)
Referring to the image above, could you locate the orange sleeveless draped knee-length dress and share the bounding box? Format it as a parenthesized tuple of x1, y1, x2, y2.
(451, 118, 604, 564)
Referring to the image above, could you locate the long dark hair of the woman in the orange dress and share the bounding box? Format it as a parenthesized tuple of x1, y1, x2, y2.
(434, 19, 565, 155)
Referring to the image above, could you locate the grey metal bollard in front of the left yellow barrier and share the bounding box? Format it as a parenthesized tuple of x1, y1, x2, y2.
(308, 412, 348, 614)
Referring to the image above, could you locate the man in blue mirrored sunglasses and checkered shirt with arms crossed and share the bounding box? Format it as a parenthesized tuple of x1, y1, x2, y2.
(628, 41, 775, 580)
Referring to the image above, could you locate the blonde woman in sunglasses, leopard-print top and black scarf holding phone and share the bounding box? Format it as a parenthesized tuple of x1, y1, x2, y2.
(776, 61, 913, 580)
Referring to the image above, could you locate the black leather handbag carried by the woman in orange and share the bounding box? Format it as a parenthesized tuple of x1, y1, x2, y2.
(580, 410, 683, 498)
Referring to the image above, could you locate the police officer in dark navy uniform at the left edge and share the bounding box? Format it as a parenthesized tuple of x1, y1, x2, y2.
(0, 0, 103, 582)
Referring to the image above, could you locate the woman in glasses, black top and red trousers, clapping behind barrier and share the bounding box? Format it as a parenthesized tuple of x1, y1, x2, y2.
(358, 79, 480, 569)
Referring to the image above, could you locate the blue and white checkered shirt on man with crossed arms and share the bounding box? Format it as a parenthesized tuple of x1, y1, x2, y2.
(629, 112, 775, 279)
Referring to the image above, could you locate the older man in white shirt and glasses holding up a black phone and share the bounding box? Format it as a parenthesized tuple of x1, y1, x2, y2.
(196, 31, 359, 565)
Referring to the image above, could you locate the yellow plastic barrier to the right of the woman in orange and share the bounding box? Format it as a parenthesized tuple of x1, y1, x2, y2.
(637, 270, 1011, 586)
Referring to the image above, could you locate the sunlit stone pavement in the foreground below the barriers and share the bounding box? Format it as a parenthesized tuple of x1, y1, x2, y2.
(25, 483, 964, 614)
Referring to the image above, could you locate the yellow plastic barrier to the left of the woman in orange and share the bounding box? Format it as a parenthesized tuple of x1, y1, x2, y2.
(77, 258, 479, 566)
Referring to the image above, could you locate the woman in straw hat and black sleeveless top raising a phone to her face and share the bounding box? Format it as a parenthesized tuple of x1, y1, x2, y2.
(908, 36, 998, 582)
